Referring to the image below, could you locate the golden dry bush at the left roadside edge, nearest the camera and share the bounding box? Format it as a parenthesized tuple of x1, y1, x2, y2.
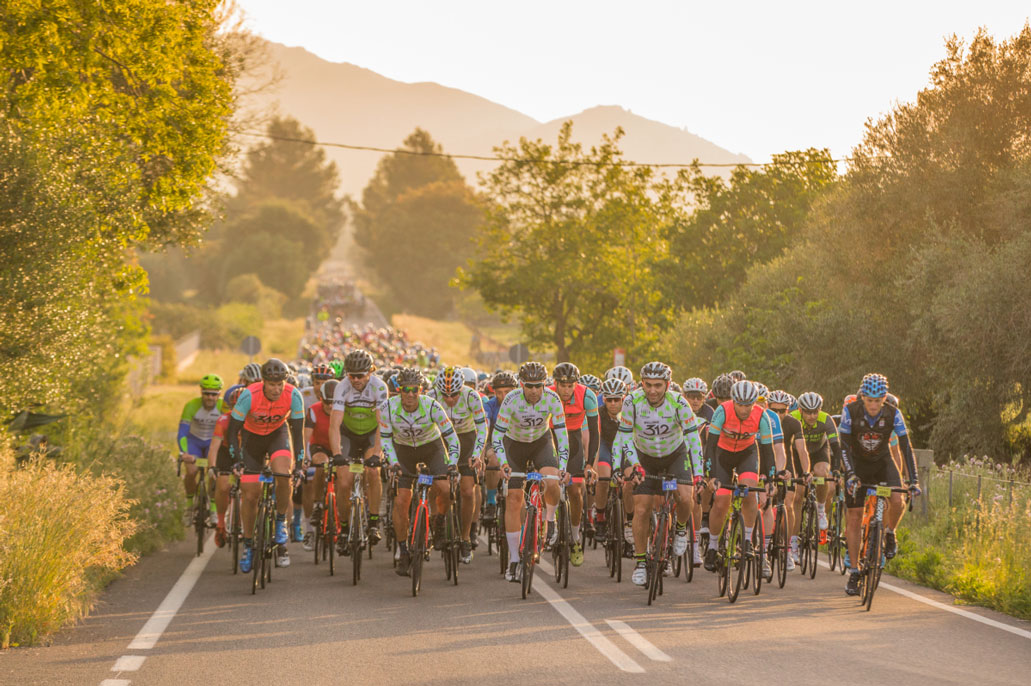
(0, 451, 136, 648)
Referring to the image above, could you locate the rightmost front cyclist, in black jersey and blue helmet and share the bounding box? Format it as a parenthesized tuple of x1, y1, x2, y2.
(838, 373, 921, 595)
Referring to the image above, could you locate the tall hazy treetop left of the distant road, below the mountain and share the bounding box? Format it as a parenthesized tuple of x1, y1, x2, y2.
(228, 117, 344, 243)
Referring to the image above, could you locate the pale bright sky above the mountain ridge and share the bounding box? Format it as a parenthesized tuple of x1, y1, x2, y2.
(239, 0, 1031, 161)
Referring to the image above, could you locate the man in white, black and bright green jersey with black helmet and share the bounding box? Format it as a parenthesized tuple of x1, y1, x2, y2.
(329, 348, 389, 555)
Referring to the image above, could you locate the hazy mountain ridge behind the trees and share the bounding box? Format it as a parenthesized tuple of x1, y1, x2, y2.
(246, 42, 750, 197)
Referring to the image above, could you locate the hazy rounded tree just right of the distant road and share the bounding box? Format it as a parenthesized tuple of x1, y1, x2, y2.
(352, 129, 481, 317)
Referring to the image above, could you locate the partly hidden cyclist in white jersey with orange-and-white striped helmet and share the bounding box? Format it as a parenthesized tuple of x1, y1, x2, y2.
(426, 367, 487, 564)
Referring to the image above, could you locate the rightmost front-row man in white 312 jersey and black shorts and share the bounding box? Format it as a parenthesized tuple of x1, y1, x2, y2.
(612, 362, 702, 586)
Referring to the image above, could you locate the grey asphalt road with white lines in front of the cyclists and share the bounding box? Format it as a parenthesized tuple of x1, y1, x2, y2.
(0, 526, 1031, 686)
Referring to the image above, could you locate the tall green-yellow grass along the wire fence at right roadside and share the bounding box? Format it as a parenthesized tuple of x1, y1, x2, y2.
(888, 458, 1031, 619)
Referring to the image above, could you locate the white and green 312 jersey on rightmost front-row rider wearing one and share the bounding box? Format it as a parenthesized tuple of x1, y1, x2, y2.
(612, 389, 702, 473)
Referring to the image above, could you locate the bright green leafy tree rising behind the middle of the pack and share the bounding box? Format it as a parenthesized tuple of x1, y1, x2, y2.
(459, 122, 683, 364)
